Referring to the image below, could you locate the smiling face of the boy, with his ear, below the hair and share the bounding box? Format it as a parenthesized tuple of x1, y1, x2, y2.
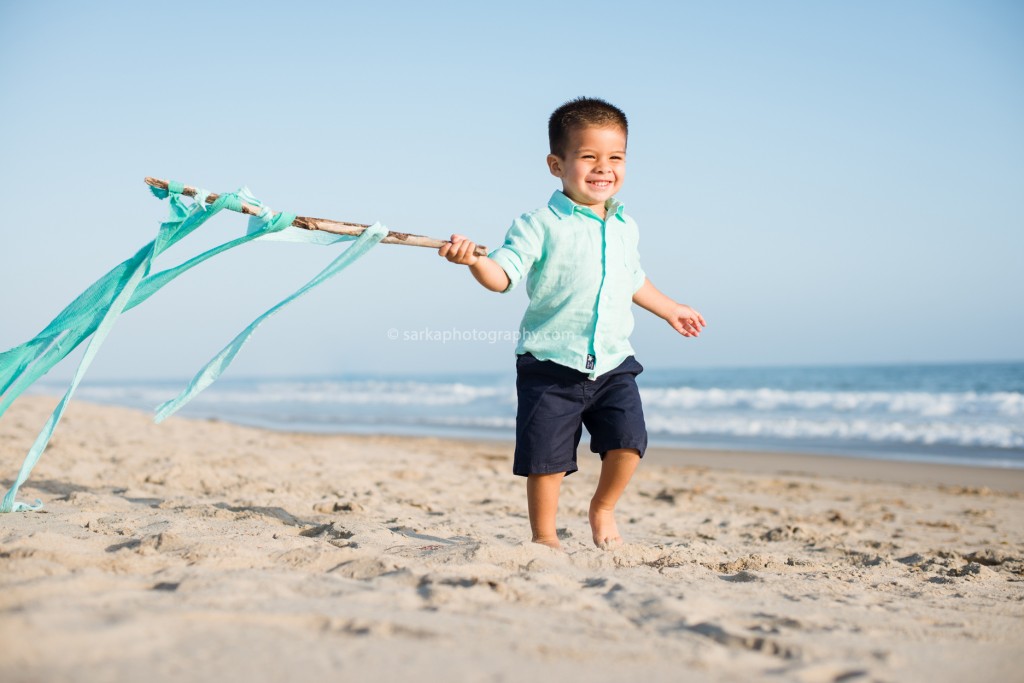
(548, 126, 626, 216)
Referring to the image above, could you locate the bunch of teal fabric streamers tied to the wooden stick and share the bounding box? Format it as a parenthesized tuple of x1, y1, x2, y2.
(0, 181, 387, 512)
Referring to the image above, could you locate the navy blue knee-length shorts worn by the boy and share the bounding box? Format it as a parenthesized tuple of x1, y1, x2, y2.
(512, 353, 647, 476)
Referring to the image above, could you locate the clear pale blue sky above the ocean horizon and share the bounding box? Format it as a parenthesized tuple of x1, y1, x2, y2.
(0, 1, 1024, 378)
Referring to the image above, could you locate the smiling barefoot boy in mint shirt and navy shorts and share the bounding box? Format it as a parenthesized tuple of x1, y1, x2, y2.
(438, 97, 706, 549)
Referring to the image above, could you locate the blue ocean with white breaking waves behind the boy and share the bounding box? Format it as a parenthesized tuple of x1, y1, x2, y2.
(37, 362, 1024, 468)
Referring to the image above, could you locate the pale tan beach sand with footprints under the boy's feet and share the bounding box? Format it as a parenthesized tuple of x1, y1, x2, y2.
(0, 397, 1024, 683)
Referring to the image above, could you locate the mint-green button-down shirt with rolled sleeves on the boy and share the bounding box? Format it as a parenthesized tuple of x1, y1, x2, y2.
(489, 190, 646, 379)
